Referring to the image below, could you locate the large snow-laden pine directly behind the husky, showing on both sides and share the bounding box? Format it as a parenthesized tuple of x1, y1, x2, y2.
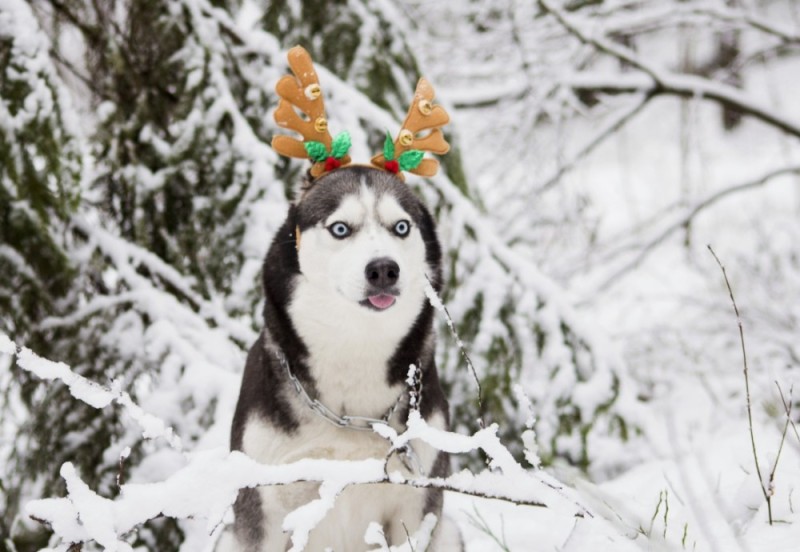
(0, 0, 636, 550)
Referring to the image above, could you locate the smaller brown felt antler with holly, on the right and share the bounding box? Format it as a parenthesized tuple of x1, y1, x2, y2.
(371, 78, 450, 178)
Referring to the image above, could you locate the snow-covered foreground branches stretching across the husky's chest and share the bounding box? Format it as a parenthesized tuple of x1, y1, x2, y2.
(0, 334, 593, 552)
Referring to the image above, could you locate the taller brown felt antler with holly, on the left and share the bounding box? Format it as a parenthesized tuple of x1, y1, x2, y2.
(272, 46, 350, 178)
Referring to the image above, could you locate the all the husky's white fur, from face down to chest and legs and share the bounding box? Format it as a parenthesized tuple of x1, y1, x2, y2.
(227, 186, 445, 552)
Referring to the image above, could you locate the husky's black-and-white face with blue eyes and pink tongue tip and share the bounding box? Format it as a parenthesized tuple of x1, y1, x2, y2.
(292, 167, 440, 344)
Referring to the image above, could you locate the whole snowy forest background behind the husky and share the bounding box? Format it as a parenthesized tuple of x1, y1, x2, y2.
(0, 0, 800, 551)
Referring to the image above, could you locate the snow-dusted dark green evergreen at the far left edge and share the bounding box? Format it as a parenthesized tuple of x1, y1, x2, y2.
(0, 0, 82, 354)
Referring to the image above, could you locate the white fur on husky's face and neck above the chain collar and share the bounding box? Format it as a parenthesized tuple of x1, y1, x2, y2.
(289, 183, 426, 418)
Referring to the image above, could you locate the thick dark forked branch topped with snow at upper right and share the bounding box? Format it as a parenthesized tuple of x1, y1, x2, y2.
(539, 0, 800, 138)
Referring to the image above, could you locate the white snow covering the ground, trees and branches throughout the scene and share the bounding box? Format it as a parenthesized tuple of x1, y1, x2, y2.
(0, 0, 800, 552)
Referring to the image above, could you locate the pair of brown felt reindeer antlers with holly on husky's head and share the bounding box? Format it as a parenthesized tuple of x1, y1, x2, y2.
(272, 46, 450, 179)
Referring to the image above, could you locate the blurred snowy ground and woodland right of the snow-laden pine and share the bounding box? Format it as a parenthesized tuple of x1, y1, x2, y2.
(411, 1, 800, 552)
